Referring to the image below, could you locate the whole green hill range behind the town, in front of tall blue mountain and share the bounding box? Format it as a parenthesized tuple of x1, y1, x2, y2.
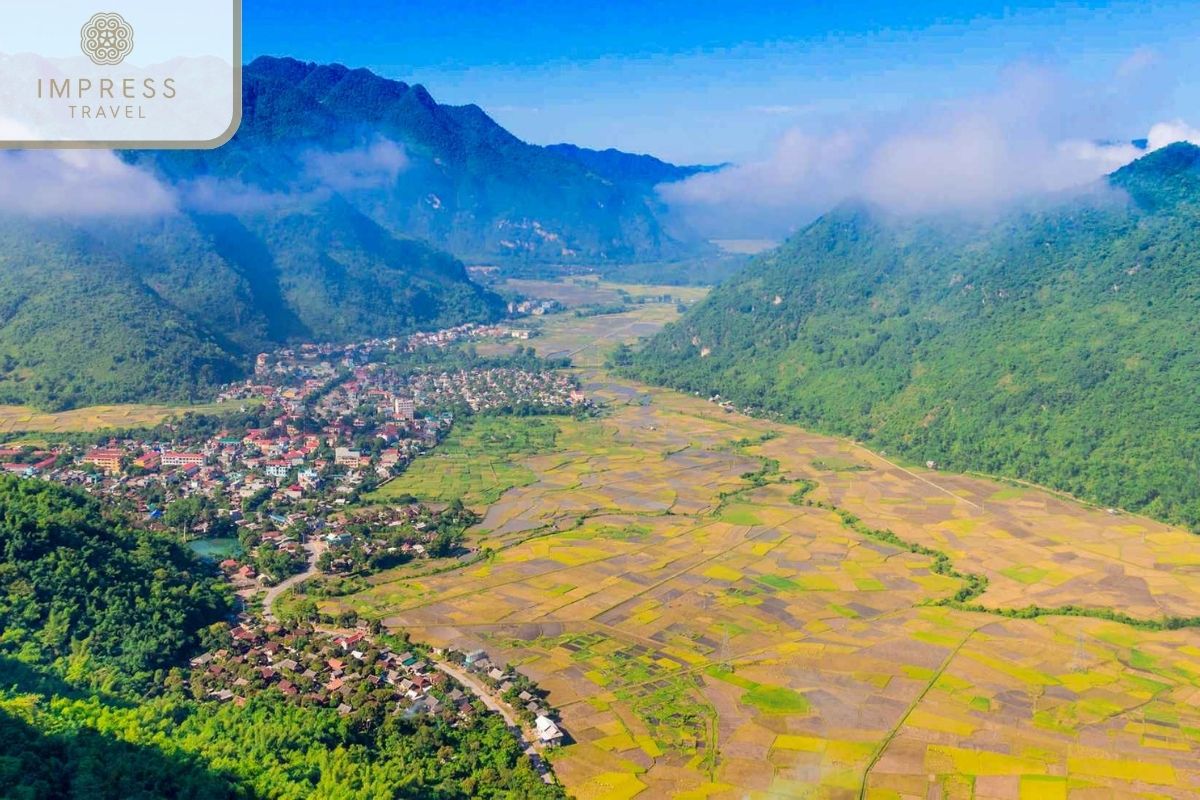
(0, 194, 500, 409)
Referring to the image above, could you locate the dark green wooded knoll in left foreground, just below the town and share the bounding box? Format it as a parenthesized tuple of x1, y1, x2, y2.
(0, 476, 229, 691)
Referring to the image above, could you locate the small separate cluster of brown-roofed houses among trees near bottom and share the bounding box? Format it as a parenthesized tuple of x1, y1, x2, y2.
(190, 620, 474, 715)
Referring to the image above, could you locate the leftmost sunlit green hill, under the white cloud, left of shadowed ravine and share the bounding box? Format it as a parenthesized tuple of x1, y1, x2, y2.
(0, 215, 240, 408)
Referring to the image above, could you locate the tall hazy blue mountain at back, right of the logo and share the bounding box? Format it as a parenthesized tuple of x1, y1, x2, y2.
(136, 56, 707, 264)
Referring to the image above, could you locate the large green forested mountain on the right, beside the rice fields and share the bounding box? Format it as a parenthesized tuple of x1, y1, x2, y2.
(622, 144, 1200, 528)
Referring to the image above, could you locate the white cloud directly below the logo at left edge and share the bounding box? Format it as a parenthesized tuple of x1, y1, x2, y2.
(0, 150, 176, 218)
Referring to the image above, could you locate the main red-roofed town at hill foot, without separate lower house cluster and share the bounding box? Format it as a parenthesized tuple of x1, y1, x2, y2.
(0, 325, 589, 582)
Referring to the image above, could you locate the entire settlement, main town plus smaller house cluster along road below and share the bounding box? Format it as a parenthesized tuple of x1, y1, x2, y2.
(0, 316, 590, 762)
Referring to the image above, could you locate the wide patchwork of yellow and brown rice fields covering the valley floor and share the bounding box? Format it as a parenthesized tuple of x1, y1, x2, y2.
(326, 373, 1200, 800)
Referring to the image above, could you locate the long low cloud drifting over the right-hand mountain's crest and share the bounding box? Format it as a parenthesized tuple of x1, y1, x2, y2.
(659, 61, 1200, 236)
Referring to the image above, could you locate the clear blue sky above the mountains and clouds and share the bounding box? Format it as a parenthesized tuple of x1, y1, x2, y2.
(245, 0, 1200, 162)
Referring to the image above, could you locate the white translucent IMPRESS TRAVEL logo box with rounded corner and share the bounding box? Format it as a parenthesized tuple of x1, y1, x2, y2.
(0, 0, 242, 148)
